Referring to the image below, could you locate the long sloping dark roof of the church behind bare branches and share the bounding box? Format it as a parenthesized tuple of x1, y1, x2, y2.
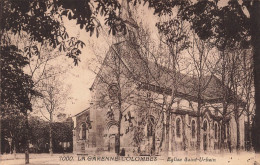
(91, 41, 244, 103)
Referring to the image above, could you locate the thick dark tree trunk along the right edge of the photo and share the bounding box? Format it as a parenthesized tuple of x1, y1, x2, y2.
(250, 0, 260, 152)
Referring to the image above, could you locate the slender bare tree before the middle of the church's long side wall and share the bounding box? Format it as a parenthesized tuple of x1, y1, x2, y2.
(188, 32, 219, 152)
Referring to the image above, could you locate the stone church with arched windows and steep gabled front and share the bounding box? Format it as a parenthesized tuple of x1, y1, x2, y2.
(73, 0, 245, 155)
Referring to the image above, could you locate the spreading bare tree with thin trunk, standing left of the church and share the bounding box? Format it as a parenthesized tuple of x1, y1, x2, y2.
(14, 35, 74, 155)
